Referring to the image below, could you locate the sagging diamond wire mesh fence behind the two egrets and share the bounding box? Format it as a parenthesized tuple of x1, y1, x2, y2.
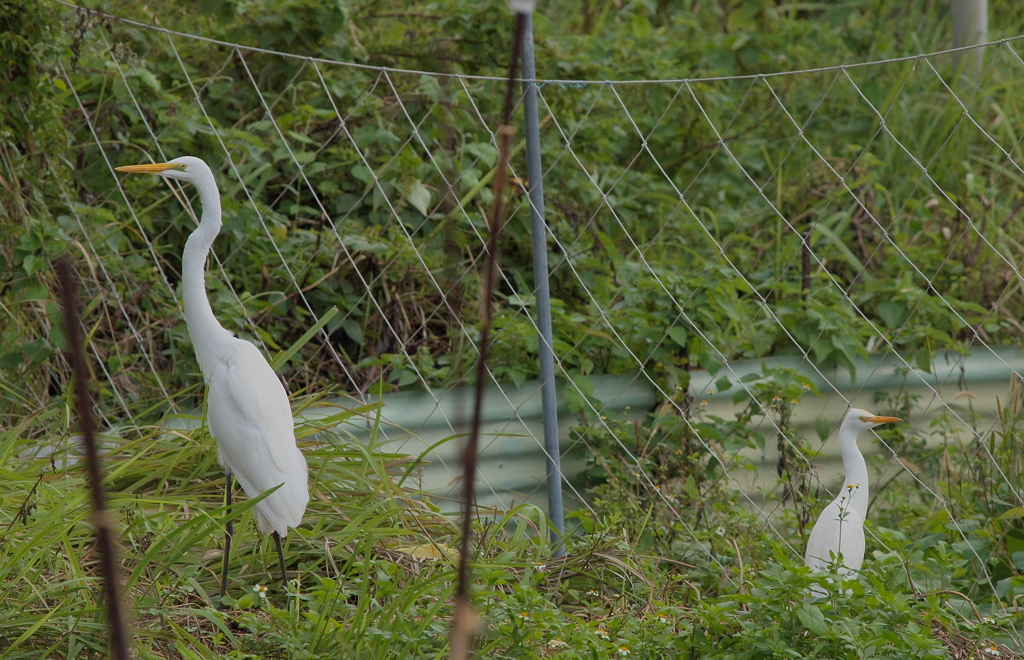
(19, 2, 1024, 626)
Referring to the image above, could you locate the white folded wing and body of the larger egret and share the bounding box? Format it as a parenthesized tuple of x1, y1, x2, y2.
(207, 340, 309, 535)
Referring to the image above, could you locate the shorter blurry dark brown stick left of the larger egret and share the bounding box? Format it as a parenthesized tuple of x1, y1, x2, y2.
(56, 259, 131, 660)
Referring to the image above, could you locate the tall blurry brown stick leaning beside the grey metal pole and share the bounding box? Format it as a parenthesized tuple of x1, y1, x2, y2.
(450, 13, 526, 660)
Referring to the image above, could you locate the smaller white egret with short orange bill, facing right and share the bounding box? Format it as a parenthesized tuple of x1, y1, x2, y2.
(804, 408, 902, 592)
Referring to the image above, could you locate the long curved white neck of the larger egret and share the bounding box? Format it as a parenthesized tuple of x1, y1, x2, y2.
(181, 169, 231, 380)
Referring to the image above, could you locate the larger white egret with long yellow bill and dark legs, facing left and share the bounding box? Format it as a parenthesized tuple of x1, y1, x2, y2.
(117, 156, 309, 598)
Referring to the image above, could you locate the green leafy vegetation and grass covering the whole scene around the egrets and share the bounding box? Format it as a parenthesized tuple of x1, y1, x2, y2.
(6, 0, 1024, 659)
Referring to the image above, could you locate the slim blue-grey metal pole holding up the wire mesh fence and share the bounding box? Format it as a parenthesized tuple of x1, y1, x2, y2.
(522, 16, 565, 557)
